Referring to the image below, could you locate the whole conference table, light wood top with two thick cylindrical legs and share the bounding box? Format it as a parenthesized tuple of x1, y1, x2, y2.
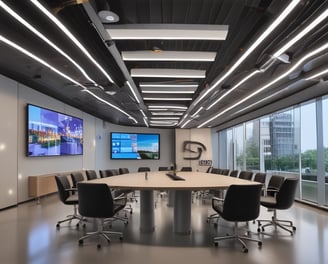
(92, 171, 260, 234)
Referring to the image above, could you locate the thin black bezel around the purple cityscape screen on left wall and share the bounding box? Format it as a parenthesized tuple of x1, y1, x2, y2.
(25, 104, 84, 158)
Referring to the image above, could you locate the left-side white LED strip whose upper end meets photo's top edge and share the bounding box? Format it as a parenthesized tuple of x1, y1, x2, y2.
(30, 0, 114, 83)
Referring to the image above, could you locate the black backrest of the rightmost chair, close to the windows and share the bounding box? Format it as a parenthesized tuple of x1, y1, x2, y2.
(275, 178, 299, 209)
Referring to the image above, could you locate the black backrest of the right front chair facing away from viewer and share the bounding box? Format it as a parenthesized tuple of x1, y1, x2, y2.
(221, 184, 262, 222)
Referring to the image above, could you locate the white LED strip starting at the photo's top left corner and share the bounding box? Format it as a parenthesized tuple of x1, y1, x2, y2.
(0, 1, 99, 86)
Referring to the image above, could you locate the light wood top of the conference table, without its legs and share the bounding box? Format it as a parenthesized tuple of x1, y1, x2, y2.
(92, 171, 260, 190)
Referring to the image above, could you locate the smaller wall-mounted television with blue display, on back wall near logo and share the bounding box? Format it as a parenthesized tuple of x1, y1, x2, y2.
(110, 132, 160, 160)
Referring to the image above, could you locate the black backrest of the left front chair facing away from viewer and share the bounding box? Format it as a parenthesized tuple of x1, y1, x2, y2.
(77, 182, 115, 218)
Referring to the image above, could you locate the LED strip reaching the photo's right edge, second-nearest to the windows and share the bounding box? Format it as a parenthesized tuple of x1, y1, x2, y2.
(197, 43, 328, 128)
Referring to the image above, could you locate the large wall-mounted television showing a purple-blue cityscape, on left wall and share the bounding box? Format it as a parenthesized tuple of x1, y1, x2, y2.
(26, 104, 83, 157)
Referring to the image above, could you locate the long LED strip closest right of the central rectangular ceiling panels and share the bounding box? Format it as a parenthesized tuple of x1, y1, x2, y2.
(193, 0, 300, 105)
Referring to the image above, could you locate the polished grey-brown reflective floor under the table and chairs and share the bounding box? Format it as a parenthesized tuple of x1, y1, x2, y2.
(0, 192, 328, 264)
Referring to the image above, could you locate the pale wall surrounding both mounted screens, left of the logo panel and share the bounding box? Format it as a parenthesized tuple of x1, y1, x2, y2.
(0, 75, 175, 209)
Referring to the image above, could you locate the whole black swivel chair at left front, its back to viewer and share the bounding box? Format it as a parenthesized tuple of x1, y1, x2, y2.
(77, 183, 126, 248)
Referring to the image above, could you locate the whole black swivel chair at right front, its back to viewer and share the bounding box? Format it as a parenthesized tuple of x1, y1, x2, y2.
(212, 184, 262, 253)
